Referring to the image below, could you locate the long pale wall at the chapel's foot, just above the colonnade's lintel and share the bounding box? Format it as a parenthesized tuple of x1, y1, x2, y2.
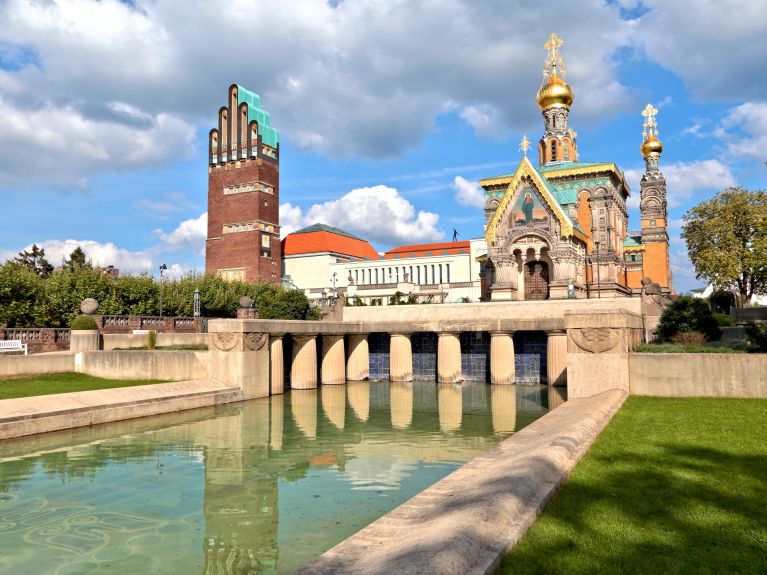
(344, 297, 642, 322)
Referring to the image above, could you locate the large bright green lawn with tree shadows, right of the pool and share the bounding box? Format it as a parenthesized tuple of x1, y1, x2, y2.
(498, 397, 767, 575)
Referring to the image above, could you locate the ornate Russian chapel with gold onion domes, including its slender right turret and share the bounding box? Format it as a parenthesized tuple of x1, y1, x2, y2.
(480, 34, 672, 301)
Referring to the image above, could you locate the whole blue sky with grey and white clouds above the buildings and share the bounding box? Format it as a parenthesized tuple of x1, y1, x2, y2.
(0, 0, 767, 292)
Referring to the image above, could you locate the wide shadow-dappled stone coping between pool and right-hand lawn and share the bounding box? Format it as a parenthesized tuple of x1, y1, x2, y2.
(296, 390, 628, 575)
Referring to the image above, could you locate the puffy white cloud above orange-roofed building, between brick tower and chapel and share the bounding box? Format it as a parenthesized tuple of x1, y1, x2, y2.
(280, 186, 444, 245)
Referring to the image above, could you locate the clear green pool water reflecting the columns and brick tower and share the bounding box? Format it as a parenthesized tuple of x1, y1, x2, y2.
(0, 382, 561, 575)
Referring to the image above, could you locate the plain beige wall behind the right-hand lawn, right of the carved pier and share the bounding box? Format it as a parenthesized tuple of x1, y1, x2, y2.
(629, 353, 767, 397)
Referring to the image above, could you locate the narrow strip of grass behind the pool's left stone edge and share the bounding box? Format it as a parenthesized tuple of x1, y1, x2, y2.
(0, 373, 166, 399)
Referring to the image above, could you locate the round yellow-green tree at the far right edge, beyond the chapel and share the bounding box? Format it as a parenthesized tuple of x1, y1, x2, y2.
(682, 187, 767, 302)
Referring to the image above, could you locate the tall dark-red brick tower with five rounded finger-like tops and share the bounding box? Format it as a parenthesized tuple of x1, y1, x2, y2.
(205, 84, 281, 283)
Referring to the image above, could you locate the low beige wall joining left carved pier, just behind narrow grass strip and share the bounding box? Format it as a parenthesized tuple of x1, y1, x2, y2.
(75, 351, 208, 381)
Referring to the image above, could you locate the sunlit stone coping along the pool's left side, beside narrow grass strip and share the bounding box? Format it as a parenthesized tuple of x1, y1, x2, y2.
(0, 380, 243, 441)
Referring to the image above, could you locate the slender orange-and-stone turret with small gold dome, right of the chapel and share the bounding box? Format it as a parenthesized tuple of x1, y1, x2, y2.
(639, 104, 673, 292)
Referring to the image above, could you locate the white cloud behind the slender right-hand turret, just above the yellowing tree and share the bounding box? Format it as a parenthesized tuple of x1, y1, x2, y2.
(624, 160, 737, 208)
